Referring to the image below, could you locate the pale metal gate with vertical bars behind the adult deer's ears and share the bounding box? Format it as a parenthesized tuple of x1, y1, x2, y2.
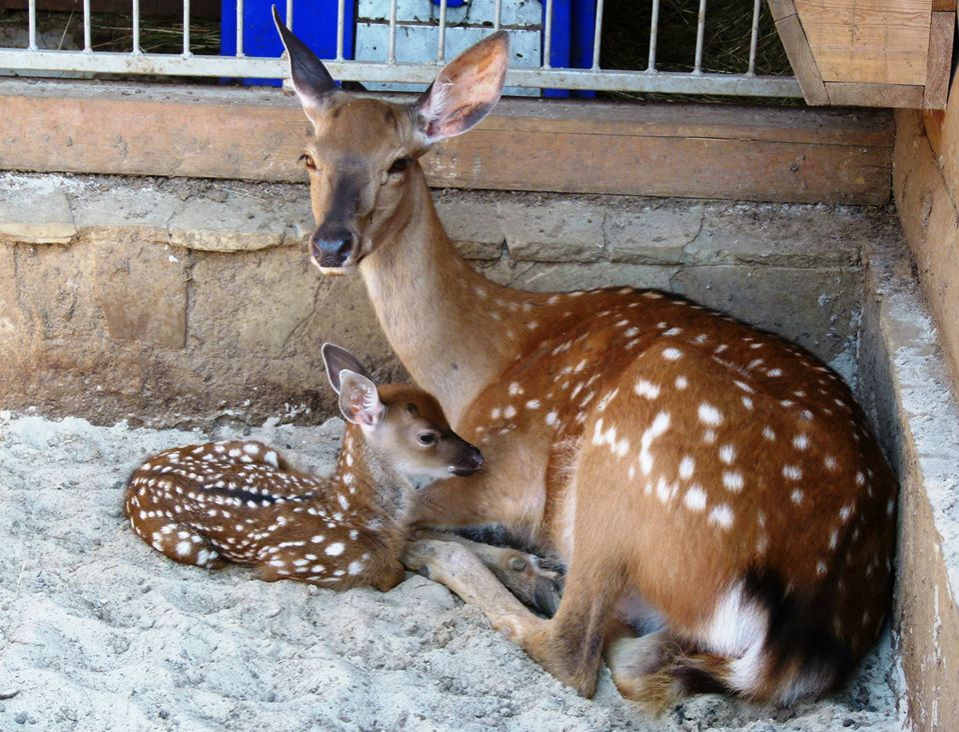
(0, 0, 802, 97)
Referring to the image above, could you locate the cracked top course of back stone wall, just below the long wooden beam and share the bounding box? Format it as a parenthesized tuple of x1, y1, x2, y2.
(0, 173, 863, 268)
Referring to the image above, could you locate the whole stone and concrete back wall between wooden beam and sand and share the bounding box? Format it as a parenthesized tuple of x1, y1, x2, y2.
(0, 174, 876, 426)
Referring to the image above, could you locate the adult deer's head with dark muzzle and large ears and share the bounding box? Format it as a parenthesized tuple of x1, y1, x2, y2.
(273, 6, 509, 274)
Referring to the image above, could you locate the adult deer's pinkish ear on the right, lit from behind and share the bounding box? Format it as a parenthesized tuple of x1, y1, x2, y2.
(415, 31, 509, 143)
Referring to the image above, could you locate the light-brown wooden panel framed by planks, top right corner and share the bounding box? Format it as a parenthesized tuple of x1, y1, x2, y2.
(795, 0, 932, 86)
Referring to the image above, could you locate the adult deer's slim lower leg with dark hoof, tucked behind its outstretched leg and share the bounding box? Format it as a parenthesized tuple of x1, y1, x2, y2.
(415, 531, 565, 616)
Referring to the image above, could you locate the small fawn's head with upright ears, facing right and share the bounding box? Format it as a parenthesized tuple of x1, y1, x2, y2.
(323, 343, 483, 478)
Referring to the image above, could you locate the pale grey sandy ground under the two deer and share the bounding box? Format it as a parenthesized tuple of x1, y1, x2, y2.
(0, 412, 903, 732)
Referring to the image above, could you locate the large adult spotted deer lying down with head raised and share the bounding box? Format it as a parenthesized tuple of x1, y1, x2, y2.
(278, 11, 897, 708)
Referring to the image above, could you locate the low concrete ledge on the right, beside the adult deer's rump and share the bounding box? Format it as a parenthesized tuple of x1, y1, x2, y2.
(860, 242, 959, 730)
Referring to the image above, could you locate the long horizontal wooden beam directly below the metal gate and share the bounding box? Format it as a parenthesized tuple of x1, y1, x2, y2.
(0, 81, 893, 204)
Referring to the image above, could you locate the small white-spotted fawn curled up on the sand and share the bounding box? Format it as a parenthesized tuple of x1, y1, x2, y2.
(124, 343, 483, 591)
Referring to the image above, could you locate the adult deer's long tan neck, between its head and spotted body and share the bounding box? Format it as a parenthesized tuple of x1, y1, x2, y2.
(360, 168, 535, 428)
